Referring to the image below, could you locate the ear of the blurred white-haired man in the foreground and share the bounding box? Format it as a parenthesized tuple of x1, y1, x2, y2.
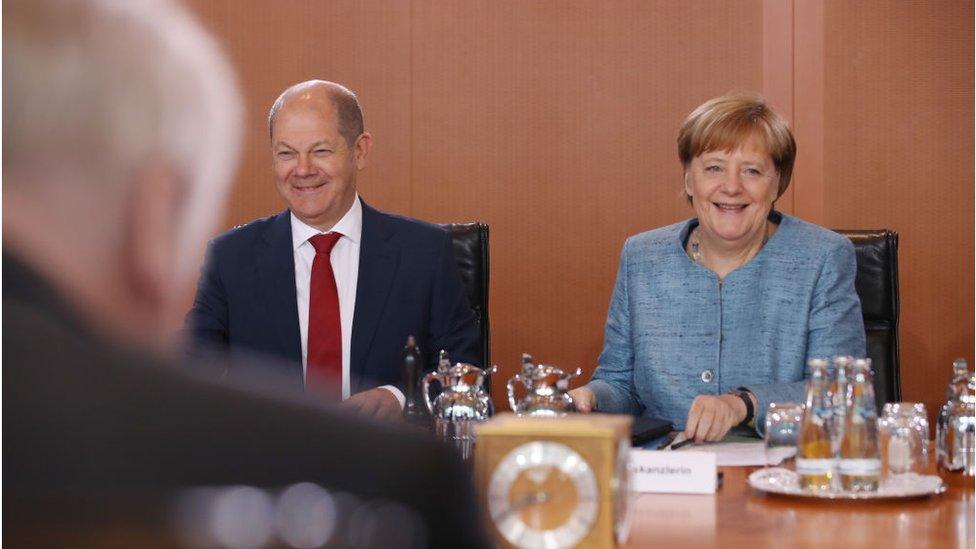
(123, 162, 184, 324)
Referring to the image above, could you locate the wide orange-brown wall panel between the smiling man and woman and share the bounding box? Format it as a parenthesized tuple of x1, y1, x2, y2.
(413, 0, 762, 394)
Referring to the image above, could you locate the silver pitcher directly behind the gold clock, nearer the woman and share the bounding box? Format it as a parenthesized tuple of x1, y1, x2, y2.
(508, 354, 583, 417)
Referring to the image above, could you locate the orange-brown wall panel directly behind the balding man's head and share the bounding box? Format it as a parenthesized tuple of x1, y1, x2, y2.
(188, 0, 411, 223)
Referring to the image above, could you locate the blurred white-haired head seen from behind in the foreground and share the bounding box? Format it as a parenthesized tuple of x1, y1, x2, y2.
(3, 0, 241, 340)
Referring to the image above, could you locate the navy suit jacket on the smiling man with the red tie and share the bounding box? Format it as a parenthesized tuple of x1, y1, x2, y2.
(186, 202, 480, 393)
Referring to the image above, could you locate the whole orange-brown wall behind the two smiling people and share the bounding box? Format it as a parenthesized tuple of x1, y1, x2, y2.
(183, 0, 974, 420)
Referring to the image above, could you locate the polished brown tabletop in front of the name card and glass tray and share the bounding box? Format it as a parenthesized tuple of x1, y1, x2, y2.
(625, 460, 976, 549)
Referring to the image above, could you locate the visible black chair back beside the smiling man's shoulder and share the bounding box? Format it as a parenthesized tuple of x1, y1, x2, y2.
(441, 223, 491, 372)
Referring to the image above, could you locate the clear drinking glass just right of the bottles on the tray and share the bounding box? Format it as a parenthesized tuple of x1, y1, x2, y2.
(878, 402, 929, 477)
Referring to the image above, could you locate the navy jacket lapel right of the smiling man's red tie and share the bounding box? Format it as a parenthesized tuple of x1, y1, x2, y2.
(350, 202, 399, 386)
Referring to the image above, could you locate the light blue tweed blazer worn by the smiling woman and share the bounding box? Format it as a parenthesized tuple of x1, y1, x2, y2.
(589, 212, 865, 433)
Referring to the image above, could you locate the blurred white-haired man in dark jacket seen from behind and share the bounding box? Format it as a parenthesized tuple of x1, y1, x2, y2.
(3, 0, 484, 546)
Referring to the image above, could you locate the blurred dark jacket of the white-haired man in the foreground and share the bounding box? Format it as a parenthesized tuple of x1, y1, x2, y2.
(3, 256, 483, 546)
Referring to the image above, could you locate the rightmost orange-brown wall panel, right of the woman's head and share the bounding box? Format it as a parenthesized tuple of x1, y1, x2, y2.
(823, 0, 974, 424)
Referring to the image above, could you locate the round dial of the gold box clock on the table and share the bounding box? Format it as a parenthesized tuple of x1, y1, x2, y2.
(488, 441, 599, 548)
